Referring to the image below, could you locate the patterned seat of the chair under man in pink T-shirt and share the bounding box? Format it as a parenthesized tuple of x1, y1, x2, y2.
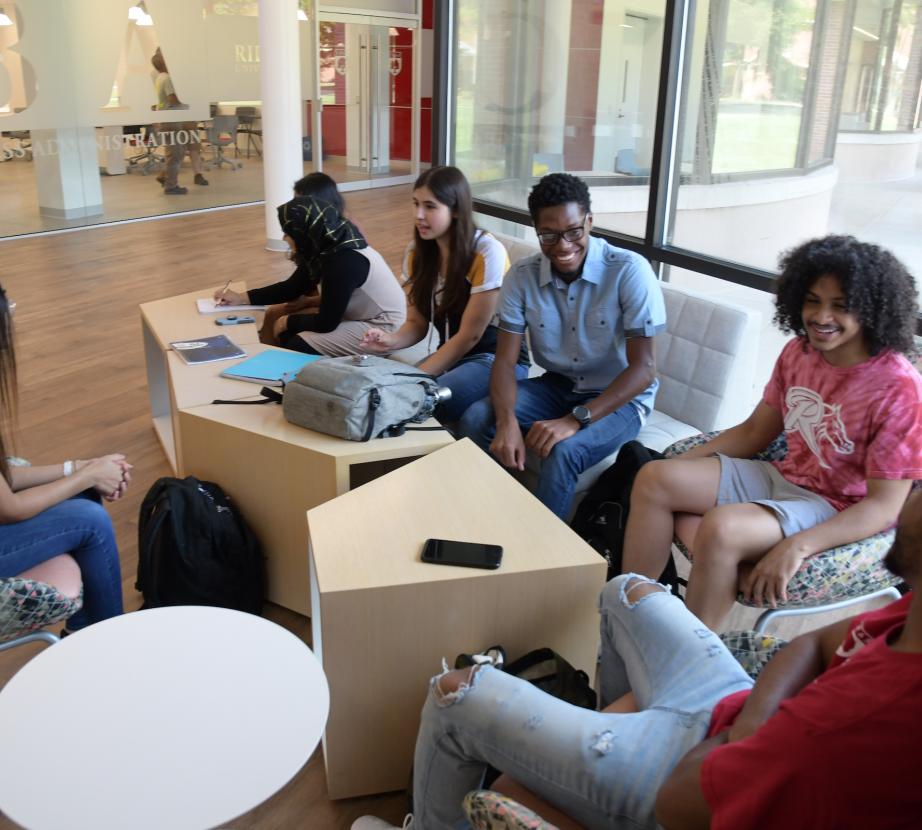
(664, 432, 901, 608)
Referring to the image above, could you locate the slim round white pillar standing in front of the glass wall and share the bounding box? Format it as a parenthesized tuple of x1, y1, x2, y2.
(259, 0, 304, 251)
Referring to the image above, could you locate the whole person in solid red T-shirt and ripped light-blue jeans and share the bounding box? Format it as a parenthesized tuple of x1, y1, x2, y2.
(353, 495, 922, 830)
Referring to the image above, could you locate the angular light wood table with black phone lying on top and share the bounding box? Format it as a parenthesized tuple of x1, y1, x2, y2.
(307, 440, 606, 798)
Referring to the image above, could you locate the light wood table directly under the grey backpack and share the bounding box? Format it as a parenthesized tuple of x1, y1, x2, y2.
(177, 404, 454, 616)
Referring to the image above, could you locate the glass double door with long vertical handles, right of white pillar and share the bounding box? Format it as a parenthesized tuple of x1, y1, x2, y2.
(318, 14, 419, 190)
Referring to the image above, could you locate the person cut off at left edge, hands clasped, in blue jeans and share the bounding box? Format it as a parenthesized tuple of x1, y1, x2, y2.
(0, 287, 131, 633)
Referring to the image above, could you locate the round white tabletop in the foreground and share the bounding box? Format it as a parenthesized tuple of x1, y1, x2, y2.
(0, 606, 330, 830)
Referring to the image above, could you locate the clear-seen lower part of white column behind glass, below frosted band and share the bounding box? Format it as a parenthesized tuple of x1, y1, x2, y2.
(32, 127, 103, 219)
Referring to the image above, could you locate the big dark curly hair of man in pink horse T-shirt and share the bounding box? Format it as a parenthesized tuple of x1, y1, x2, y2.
(774, 236, 917, 355)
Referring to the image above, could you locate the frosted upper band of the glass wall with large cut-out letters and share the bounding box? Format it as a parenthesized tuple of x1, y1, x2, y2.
(0, 0, 326, 130)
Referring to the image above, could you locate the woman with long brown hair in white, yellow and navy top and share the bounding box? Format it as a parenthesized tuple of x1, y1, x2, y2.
(361, 167, 528, 422)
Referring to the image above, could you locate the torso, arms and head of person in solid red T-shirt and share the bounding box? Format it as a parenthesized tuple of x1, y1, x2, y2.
(655, 494, 922, 830)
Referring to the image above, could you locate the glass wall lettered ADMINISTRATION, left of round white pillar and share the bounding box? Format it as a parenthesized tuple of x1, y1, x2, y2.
(0, 0, 270, 236)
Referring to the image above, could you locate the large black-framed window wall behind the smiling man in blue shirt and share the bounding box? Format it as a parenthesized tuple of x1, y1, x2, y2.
(453, 0, 922, 288)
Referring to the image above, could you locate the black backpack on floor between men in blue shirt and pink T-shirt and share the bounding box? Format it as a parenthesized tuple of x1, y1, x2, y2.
(570, 441, 680, 596)
